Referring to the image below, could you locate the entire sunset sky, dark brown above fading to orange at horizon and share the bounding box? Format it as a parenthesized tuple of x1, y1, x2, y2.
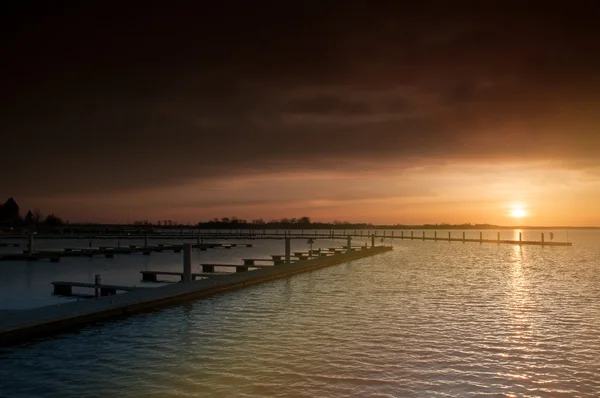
(0, 0, 600, 226)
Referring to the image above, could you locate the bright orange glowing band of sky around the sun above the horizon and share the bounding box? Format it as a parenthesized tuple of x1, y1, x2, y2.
(16, 163, 600, 226)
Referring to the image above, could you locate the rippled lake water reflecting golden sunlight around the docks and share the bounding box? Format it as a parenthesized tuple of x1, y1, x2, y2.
(0, 230, 600, 397)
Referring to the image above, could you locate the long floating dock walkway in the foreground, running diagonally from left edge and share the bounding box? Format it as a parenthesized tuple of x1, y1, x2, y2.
(0, 246, 392, 346)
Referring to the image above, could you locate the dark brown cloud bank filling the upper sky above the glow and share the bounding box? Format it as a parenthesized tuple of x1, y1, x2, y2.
(0, 1, 600, 196)
